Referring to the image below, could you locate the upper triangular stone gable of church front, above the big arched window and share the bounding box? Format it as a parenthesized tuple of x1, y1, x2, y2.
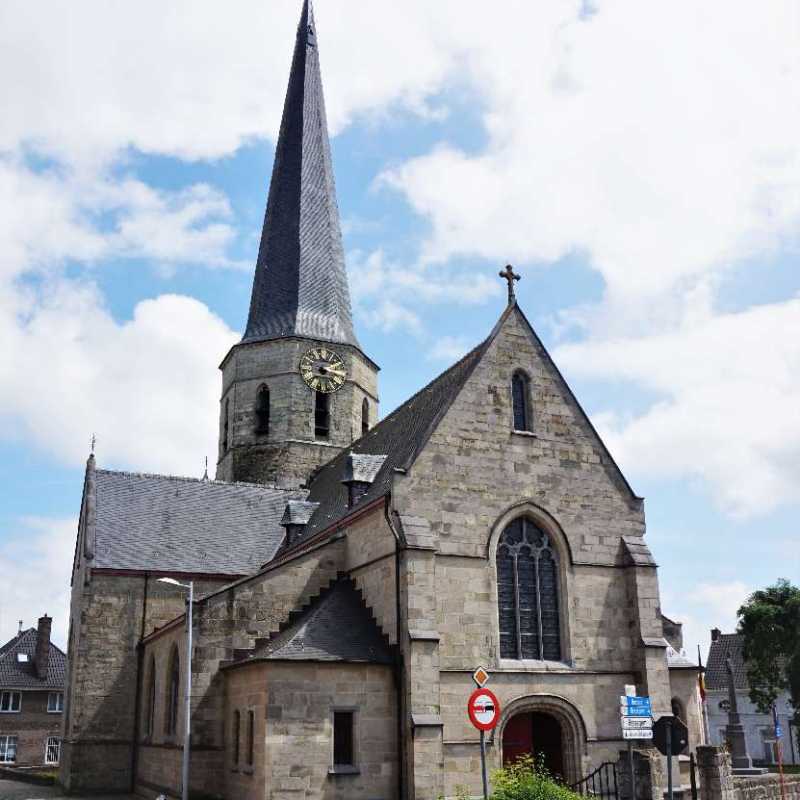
(395, 304, 644, 563)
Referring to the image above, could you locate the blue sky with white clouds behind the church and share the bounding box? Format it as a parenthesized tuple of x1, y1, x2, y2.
(0, 0, 800, 655)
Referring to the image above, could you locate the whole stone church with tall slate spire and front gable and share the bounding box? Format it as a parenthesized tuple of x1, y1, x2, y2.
(61, 0, 701, 800)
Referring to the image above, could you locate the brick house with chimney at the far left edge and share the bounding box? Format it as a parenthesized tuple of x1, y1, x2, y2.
(0, 615, 67, 767)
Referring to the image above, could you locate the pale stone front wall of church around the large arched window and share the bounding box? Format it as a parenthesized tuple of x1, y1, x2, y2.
(393, 310, 669, 800)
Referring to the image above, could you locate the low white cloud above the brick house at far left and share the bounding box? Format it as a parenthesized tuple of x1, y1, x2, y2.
(0, 517, 78, 651)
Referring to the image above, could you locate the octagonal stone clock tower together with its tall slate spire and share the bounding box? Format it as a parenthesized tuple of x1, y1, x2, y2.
(217, 0, 378, 486)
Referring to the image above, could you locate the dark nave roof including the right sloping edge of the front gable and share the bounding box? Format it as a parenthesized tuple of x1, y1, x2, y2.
(292, 303, 641, 549)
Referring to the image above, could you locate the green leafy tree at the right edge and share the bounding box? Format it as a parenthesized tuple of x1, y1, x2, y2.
(737, 580, 800, 725)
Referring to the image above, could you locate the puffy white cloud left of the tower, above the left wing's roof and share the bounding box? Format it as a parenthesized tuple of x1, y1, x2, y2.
(0, 281, 237, 476)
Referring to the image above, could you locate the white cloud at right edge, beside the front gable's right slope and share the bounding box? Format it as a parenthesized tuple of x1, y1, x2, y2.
(555, 298, 800, 517)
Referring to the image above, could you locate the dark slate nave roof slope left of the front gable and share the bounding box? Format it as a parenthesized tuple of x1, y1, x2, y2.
(284, 337, 492, 542)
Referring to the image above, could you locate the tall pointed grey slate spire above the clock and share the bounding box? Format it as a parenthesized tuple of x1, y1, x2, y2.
(242, 0, 358, 346)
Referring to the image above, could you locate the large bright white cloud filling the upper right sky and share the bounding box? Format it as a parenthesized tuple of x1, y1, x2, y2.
(384, 0, 800, 305)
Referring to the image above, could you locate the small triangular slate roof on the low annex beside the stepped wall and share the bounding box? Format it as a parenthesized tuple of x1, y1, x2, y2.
(247, 578, 392, 664)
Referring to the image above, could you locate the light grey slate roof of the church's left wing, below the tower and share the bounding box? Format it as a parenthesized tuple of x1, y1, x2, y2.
(90, 466, 305, 575)
